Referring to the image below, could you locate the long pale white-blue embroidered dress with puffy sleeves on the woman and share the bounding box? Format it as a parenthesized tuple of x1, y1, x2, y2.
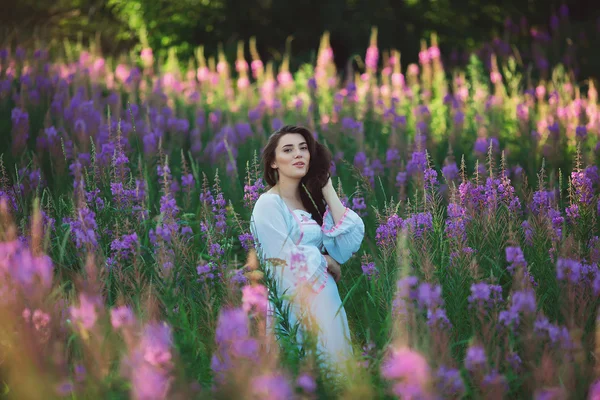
(250, 193, 365, 363)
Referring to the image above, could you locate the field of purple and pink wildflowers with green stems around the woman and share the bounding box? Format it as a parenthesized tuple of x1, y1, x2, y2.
(0, 10, 600, 399)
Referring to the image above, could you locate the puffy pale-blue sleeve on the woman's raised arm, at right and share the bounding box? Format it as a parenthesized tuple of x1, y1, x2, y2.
(321, 206, 365, 264)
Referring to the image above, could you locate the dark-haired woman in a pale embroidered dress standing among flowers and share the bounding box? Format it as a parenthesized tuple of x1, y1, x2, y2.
(251, 125, 365, 365)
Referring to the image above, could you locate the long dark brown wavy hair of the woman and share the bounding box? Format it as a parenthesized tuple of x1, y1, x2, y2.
(262, 125, 332, 226)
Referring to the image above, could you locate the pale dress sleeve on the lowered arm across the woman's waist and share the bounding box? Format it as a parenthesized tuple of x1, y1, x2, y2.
(250, 196, 329, 295)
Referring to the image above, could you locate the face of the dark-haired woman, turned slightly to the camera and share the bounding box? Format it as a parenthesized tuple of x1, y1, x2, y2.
(271, 133, 310, 179)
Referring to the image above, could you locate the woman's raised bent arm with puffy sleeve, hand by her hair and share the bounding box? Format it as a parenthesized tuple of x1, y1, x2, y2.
(321, 178, 365, 264)
